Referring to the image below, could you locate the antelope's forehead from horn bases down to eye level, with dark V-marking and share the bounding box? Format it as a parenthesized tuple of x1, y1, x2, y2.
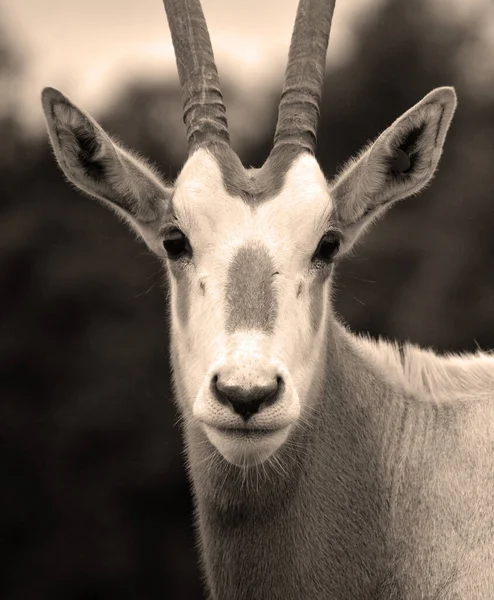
(173, 148, 332, 245)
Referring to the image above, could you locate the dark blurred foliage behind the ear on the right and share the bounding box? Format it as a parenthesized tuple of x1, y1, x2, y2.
(319, 0, 494, 350)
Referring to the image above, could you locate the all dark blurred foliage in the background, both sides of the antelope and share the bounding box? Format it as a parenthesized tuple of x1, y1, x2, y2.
(0, 0, 494, 600)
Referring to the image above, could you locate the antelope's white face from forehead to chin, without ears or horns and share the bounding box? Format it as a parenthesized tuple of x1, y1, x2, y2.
(164, 150, 338, 466)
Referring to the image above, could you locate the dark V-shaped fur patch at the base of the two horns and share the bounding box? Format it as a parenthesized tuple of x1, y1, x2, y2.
(209, 144, 301, 206)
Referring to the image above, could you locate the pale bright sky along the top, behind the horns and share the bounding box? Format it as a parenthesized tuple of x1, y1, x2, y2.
(0, 0, 494, 133)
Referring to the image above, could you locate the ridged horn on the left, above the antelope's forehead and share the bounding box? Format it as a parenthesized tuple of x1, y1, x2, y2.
(164, 0, 230, 155)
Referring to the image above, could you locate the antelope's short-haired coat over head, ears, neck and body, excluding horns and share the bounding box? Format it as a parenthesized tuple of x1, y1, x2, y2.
(39, 0, 494, 600)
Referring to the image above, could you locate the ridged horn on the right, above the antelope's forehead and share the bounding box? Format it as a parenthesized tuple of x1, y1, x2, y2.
(271, 0, 336, 154)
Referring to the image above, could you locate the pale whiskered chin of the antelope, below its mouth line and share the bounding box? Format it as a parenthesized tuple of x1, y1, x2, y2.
(204, 425, 291, 467)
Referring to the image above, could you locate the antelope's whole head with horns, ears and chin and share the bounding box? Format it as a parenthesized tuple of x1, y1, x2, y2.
(42, 0, 456, 466)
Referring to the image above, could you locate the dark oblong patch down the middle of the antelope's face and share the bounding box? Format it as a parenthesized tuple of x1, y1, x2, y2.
(226, 244, 278, 333)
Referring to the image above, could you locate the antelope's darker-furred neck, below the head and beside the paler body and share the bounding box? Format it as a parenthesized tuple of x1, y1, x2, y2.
(179, 316, 404, 600)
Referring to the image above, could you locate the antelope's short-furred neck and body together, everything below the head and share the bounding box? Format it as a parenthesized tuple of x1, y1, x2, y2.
(186, 322, 494, 600)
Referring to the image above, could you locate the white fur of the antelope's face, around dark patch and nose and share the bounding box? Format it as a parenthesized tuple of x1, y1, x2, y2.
(171, 149, 332, 462)
